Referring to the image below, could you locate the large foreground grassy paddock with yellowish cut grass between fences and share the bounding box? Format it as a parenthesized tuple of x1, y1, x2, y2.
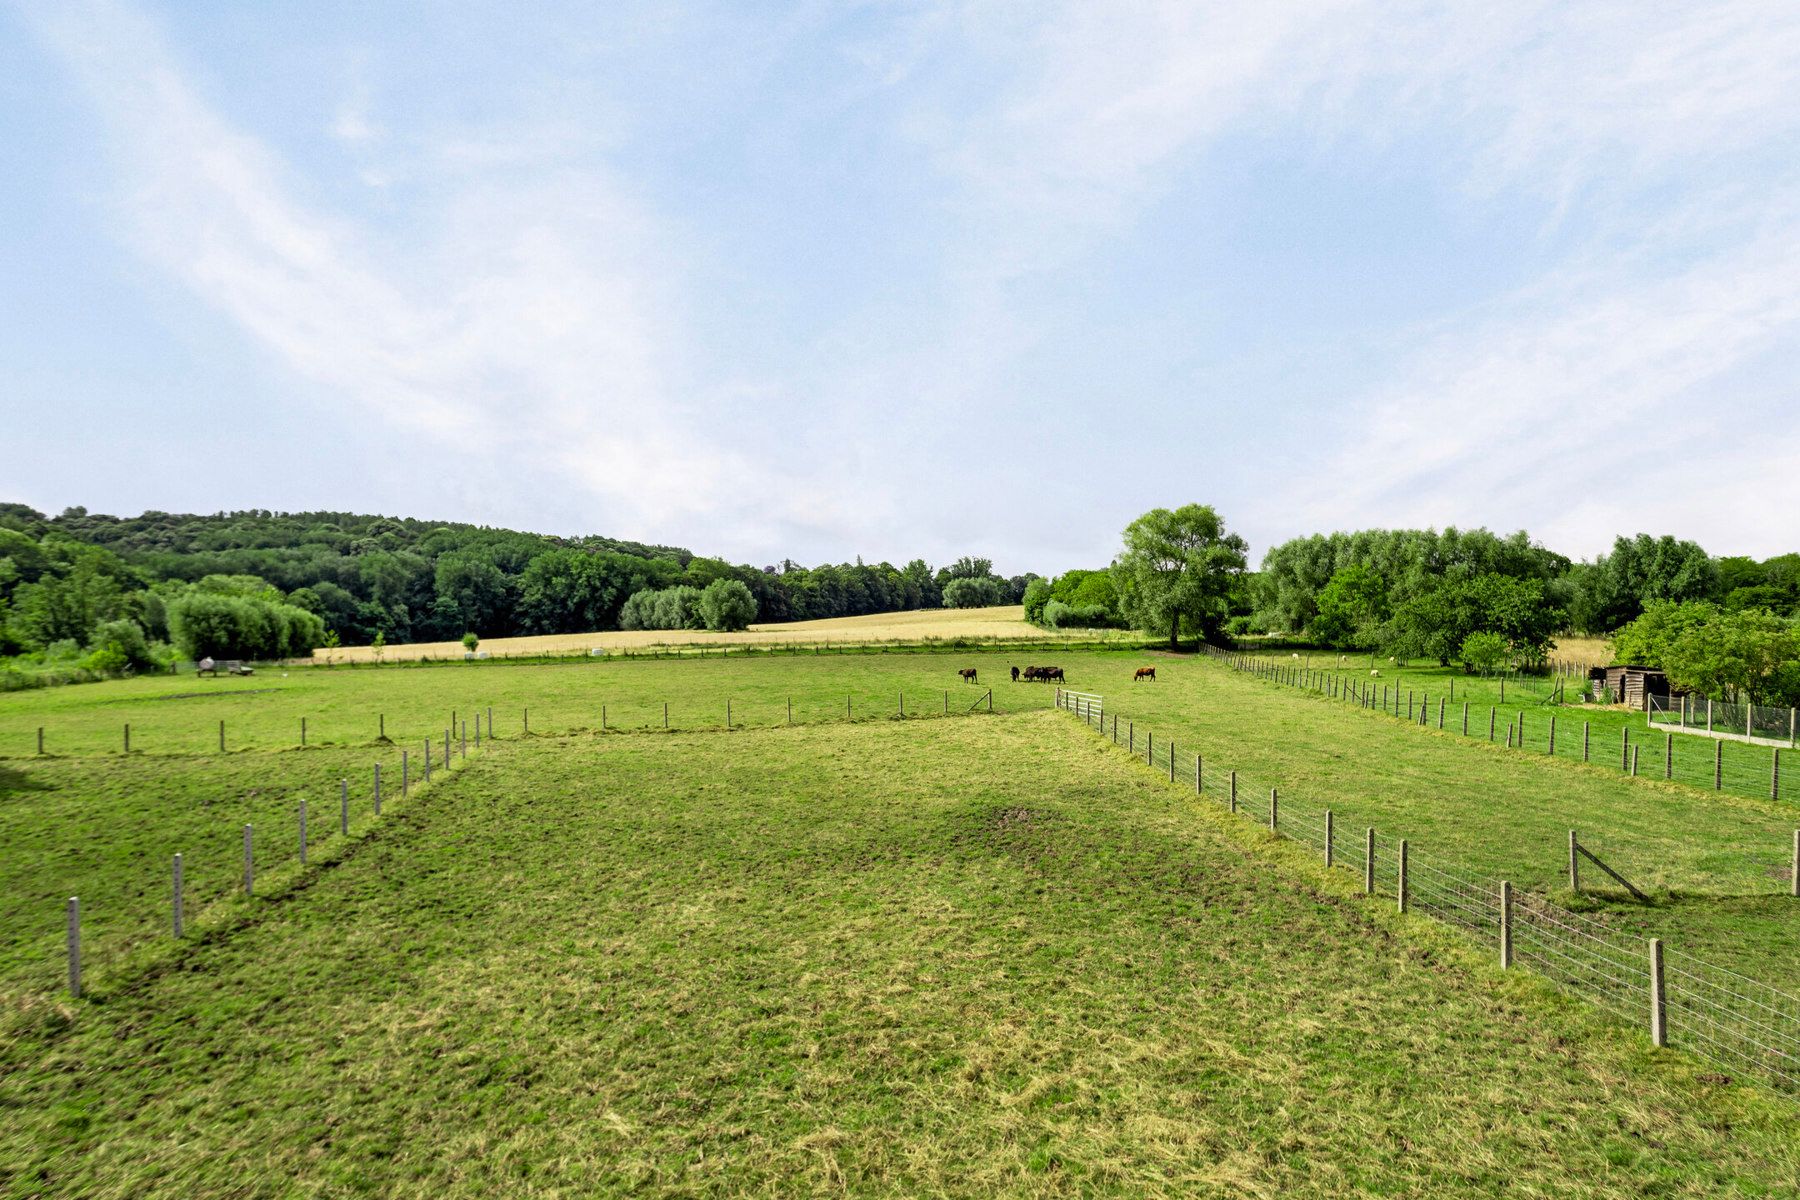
(0, 712, 1800, 1198)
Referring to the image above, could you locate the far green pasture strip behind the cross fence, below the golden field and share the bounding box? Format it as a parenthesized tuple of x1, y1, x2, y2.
(0, 649, 1065, 757)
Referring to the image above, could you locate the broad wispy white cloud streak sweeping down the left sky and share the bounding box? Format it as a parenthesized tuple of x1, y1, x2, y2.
(12, 2, 817, 543)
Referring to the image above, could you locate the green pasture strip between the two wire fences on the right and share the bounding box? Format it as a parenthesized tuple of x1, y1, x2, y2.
(1107, 658, 1800, 991)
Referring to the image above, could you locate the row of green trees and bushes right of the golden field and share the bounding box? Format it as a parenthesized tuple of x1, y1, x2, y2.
(1024, 506, 1800, 680)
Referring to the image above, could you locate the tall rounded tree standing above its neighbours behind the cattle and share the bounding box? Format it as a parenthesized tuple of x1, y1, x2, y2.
(1112, 504, 1246, 649)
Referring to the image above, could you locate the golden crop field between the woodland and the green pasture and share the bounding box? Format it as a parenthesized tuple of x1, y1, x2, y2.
(313, 604, 1129, 662)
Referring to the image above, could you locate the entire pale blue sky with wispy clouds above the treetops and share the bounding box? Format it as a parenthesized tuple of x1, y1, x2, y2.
(0, 0, 1800, 572)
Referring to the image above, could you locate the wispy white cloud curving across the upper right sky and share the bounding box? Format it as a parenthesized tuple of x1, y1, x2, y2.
(889, 0, 1800, 552)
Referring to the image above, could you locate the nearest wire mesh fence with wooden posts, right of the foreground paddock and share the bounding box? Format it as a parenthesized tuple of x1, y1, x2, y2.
(1057, 691, 1800, 1088)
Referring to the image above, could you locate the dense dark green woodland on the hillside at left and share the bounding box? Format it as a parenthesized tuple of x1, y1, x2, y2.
(0, 504, 1030, 673)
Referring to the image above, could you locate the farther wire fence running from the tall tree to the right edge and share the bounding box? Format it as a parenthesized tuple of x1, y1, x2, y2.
(1201, 646, 1800, 801)
